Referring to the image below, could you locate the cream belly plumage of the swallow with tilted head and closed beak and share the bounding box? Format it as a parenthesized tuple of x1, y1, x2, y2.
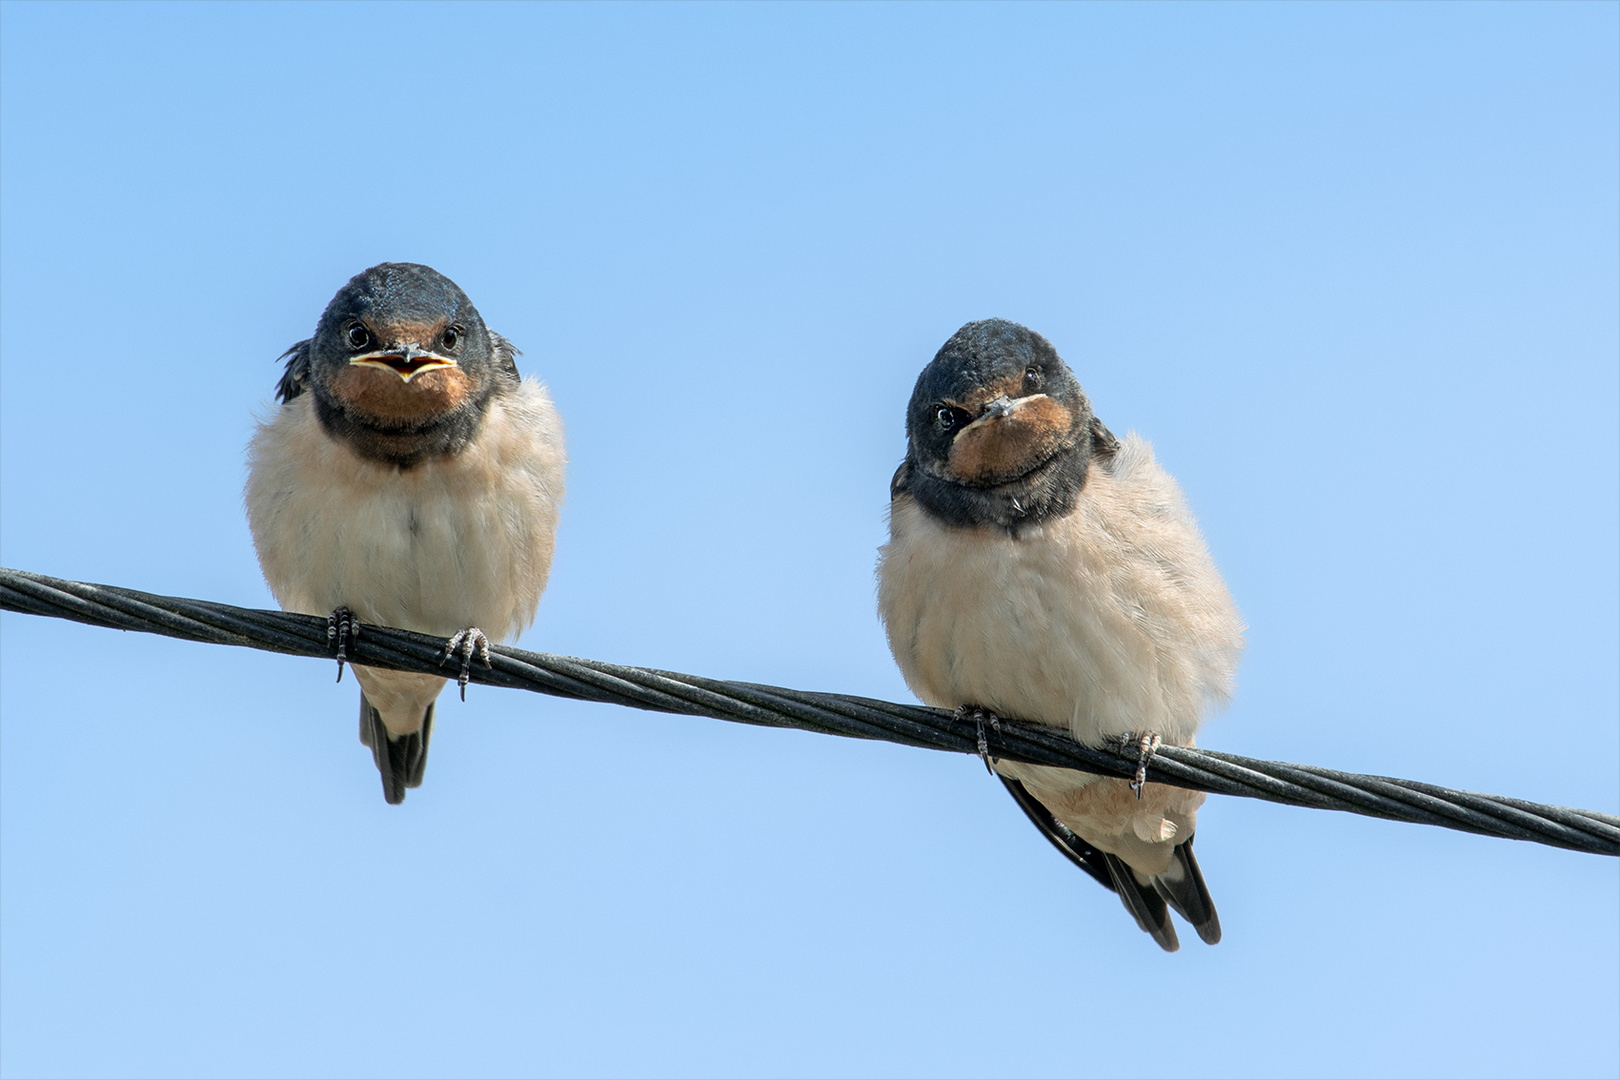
(878, 434, 1243, 874)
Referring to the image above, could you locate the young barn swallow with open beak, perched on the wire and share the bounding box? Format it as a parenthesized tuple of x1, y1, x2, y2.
(246, 262, 565, 803)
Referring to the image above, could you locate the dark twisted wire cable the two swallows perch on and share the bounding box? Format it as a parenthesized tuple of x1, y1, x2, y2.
(0, 568, 1620, 855)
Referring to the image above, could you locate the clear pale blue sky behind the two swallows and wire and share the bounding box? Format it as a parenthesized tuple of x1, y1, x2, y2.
(0, 3, 1620, 1077)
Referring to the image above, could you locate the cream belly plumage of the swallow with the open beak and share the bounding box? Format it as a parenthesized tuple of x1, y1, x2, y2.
(246, 379, 565, 735)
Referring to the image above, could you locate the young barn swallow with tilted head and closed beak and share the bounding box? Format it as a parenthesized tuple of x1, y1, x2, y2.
(878, 319, 1244, 952)
